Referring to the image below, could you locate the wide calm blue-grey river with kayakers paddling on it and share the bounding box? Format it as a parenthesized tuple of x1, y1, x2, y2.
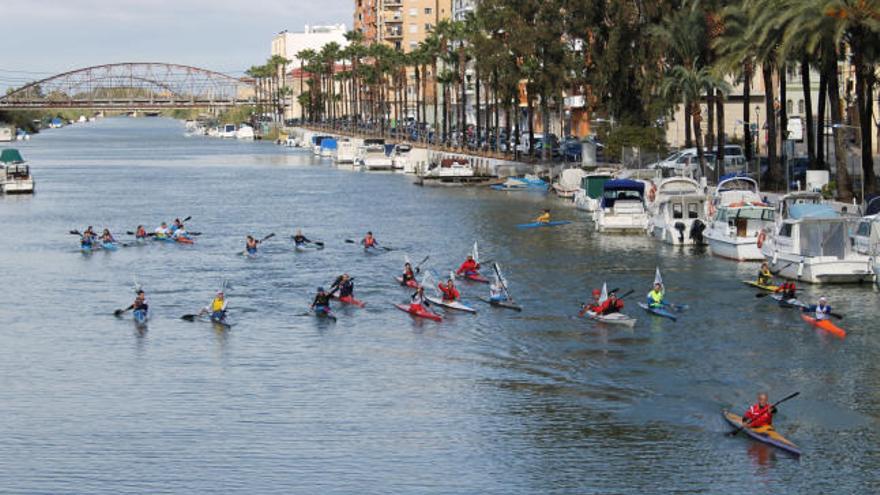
(0, 118, 880, 494)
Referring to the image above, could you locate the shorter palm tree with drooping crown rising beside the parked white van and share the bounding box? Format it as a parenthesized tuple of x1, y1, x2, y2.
(661, 63, 730, 177)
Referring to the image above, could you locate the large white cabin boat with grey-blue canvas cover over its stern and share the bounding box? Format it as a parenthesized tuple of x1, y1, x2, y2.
(761, 202, 876, 284)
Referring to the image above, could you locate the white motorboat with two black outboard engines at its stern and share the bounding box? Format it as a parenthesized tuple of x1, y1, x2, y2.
(648, 177, 707, 246)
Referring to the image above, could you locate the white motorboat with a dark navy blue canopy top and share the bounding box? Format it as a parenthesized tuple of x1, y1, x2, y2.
(593, 179, 648, 234)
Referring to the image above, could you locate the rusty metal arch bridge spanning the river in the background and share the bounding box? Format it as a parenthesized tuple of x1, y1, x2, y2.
(0, 62, 254, 110)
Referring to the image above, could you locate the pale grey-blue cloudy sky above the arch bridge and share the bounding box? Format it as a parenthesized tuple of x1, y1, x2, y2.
(0, 0, 355, 92)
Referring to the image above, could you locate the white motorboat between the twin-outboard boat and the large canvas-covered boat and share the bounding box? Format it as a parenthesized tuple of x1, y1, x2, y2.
(703, 177, 775, 261)
